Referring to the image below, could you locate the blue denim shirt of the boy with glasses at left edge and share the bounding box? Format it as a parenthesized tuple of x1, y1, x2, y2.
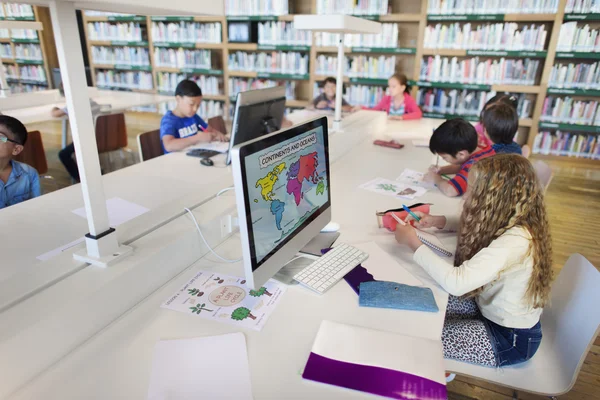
(0, 160, 41, 208)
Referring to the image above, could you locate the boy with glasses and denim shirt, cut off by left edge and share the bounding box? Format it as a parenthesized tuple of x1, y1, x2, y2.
(0, 115, 40, 208)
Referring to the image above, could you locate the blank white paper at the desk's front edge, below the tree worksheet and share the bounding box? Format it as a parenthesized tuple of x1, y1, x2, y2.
(148, 332, 252, 400)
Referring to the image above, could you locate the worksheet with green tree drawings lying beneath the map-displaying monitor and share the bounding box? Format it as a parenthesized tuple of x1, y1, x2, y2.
(162, 271, 286, 331)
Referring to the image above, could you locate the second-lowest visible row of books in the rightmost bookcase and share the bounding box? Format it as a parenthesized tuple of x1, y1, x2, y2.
(540, 96, 600, 125)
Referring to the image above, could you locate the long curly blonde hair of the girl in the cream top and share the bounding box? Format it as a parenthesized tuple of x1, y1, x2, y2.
(454, 154, 552, 308)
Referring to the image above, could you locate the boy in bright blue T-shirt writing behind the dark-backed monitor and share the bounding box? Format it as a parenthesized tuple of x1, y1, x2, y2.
(160, 79, 227, 154)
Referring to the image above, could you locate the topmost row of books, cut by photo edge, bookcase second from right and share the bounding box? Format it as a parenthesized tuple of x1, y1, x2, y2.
(427, 0, 559, 15)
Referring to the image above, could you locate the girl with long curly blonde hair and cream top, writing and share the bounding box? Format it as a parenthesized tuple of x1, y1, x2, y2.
(396, 154, 552, 367)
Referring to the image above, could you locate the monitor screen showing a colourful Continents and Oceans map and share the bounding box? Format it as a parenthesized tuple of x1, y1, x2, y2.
(240, 119, 331, 271)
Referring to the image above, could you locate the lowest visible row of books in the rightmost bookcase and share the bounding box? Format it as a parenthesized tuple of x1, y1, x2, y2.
(532, 131, 600, 160)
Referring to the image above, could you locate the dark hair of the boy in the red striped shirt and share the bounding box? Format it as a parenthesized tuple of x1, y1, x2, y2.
(429, 118, 477, 157)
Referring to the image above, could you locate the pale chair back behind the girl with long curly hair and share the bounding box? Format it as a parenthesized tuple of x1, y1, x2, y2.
(542, 254, 600, 387)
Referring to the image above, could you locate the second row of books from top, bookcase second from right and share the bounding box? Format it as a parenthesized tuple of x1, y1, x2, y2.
(423, 22, 548, 51)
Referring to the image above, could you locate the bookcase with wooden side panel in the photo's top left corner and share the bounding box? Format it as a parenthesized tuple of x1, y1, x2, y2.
(0, 3, 58, 93)
